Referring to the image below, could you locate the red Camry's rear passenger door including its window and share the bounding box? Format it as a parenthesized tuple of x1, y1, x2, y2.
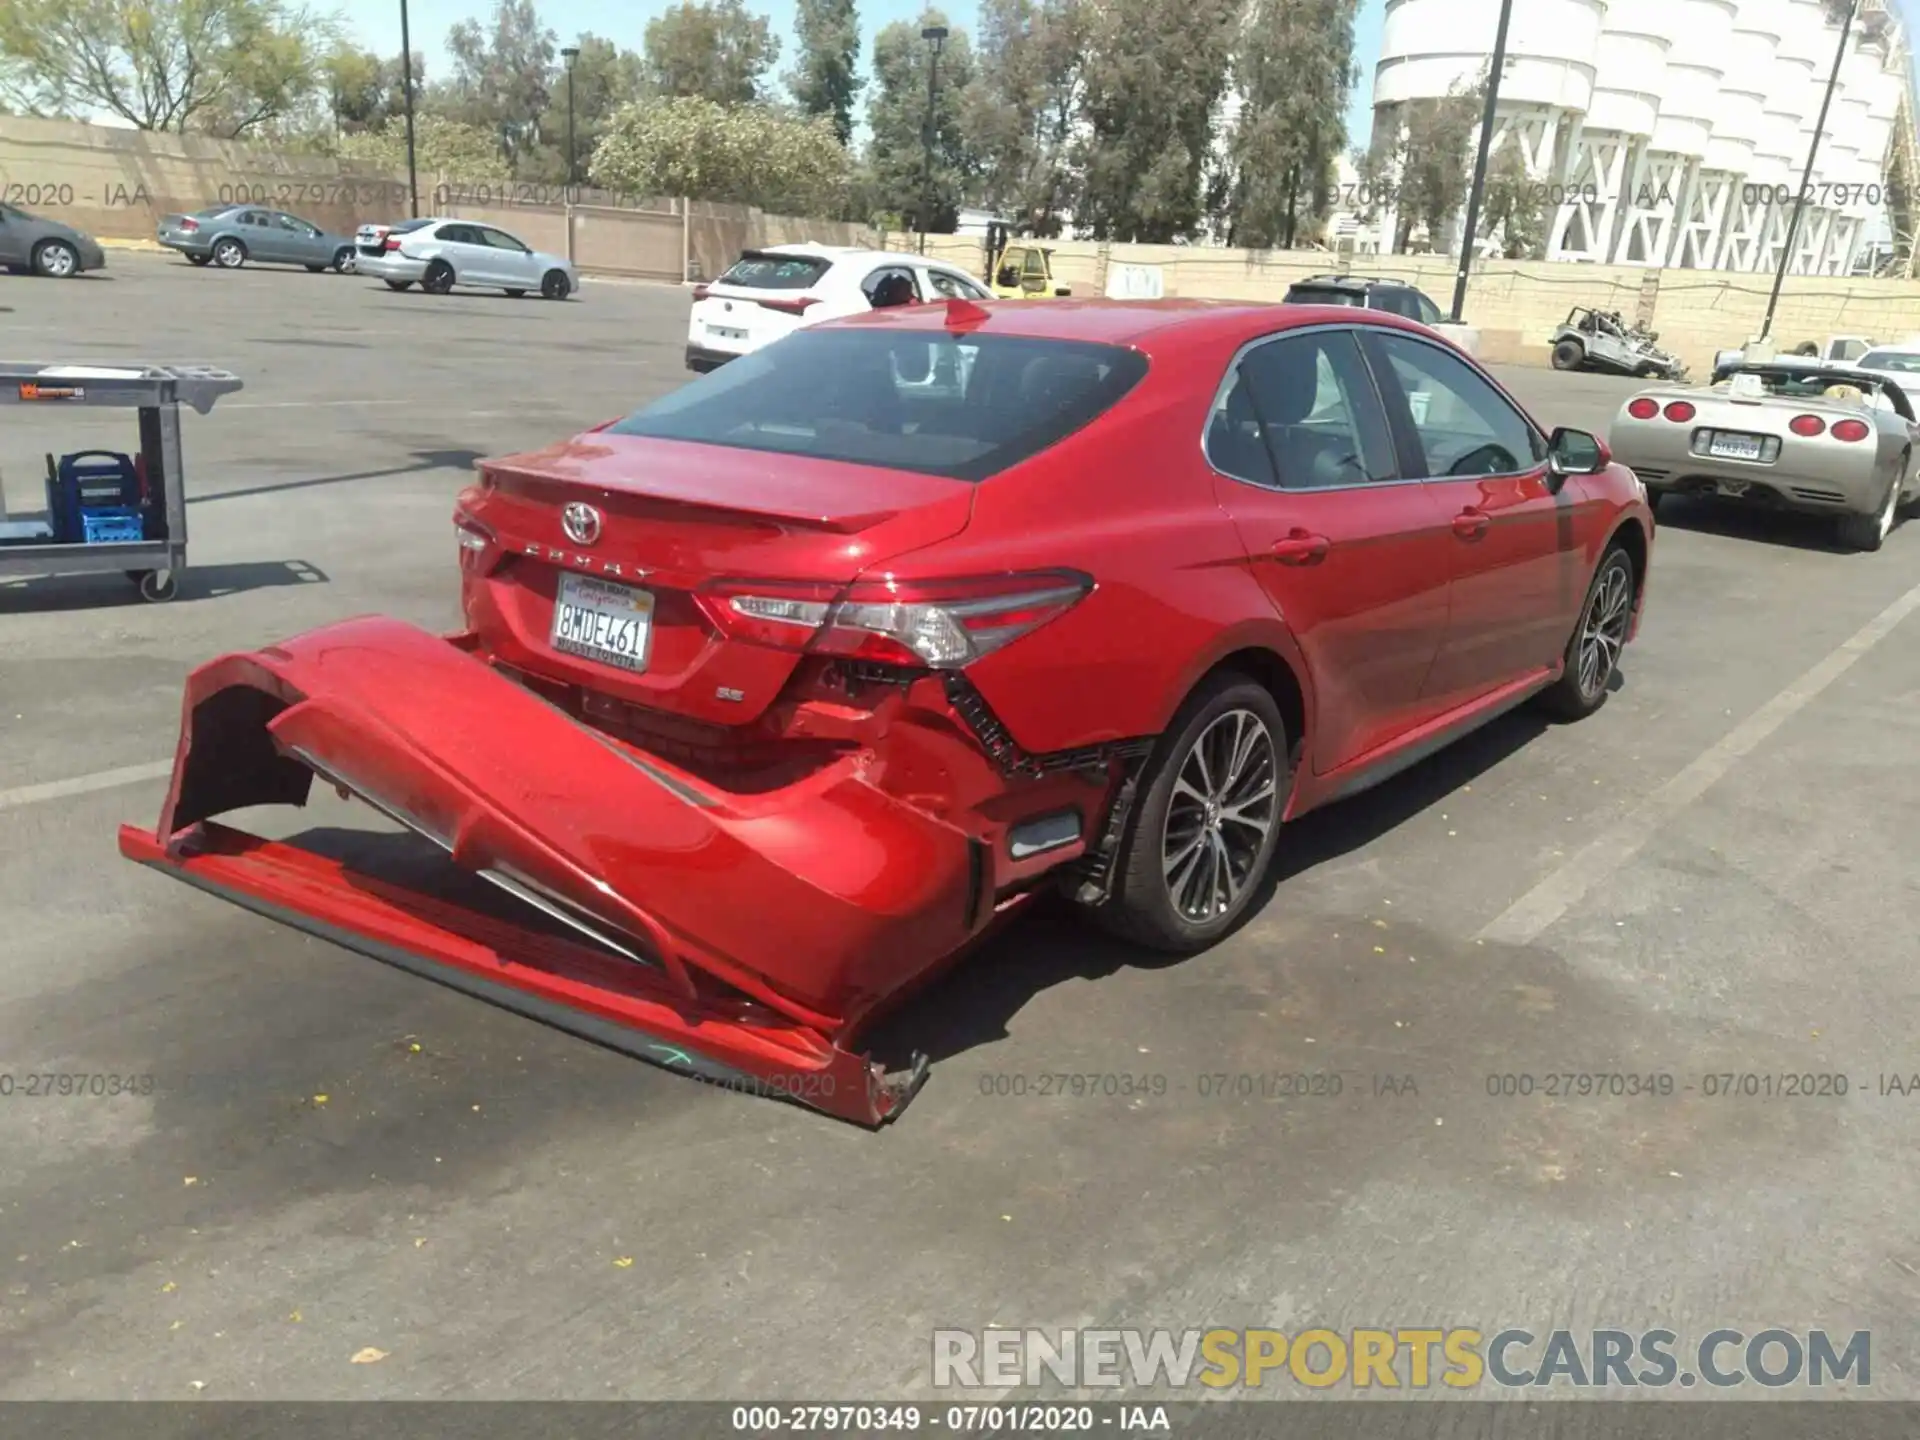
(1206, 324, 1450, 774)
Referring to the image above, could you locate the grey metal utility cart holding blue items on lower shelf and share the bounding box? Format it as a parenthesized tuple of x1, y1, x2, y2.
(0, 361, 242, 601)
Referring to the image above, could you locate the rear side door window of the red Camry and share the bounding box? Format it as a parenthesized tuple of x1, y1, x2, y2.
(1208, 330, 1398, 490)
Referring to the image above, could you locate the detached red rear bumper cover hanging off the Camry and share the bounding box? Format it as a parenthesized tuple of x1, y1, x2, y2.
(121, 618, 993, 1125)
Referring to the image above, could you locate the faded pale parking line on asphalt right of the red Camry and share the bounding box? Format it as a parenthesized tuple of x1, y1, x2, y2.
(1478, 568, 1920, 945)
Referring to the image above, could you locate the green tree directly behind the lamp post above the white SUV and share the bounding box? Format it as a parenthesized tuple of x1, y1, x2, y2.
(866, 8, 979, 230)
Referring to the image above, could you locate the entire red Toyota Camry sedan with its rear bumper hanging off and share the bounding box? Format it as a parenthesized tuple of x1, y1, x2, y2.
(121, 301, 1653, 1125)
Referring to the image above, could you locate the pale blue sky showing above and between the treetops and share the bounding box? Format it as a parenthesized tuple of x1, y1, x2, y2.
(340, 0, 1397, 142)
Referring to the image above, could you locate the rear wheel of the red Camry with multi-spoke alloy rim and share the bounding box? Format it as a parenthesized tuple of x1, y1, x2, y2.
(1094, 672, 1292, 954)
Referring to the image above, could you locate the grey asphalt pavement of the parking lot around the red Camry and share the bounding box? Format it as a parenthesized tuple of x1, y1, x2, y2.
(0, 255, 1920, 1400)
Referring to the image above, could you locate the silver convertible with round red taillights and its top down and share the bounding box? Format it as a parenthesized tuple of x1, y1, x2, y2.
(1609, 359, 1920, 551)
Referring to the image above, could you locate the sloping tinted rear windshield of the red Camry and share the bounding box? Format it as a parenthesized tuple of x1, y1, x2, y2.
(611, 328, 1146, 480)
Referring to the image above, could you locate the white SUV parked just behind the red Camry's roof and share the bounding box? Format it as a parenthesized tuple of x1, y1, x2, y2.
(687, 244, 993, 371)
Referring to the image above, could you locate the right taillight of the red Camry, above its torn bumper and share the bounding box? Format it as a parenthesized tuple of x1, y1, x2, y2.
(699, 570, 1092, 670)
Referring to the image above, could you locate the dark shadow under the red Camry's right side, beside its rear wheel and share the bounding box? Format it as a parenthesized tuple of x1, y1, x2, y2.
(864, 707, 1549, 1068)
